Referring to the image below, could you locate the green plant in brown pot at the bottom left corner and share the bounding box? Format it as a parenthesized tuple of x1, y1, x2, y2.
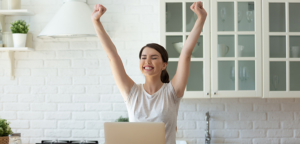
(0, 119, 13, 144)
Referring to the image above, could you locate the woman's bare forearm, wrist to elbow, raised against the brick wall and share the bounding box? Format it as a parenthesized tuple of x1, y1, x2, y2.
(93, 21, 118, 59)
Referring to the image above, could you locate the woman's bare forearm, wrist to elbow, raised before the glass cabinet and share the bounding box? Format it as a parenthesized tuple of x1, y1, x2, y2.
(181, 18, 205, 56)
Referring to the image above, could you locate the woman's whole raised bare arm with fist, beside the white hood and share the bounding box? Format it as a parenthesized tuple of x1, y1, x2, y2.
(91, 4, 134, 100)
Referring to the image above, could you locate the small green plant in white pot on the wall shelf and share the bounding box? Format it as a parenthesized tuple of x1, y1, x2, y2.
(10, 20, 29, 47)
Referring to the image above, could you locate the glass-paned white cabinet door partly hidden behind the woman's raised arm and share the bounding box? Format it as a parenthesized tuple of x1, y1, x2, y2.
(160, 0, 210, 98)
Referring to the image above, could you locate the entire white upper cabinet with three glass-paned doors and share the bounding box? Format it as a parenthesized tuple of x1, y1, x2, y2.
(160, 0, 300, 98)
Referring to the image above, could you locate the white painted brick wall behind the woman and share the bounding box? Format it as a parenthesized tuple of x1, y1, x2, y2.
(0, 0, 300, 144)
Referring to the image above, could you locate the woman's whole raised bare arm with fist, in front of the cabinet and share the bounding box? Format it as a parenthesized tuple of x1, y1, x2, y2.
(171, 1, 207, 98)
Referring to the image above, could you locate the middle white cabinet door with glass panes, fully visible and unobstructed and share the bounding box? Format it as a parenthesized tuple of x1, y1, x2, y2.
(211, 0, 262, 98)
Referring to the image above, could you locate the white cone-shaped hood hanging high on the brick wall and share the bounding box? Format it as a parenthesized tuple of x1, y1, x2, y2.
(37, 0, 96, 38)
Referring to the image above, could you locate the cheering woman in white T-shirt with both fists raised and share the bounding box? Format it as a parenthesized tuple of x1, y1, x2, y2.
(91, 1, 207, 144)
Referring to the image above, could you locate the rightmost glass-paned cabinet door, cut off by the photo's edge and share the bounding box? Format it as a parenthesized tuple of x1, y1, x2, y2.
(262, 0, 300, 98)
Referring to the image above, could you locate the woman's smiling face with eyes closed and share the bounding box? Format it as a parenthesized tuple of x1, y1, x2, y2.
(140, 47, 167, 76)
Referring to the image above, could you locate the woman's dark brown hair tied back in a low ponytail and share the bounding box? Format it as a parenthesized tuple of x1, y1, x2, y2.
(139, 43, 170, 83)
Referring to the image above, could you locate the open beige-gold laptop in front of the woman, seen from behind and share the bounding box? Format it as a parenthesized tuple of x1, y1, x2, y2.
(104, 122, 165, 144)
